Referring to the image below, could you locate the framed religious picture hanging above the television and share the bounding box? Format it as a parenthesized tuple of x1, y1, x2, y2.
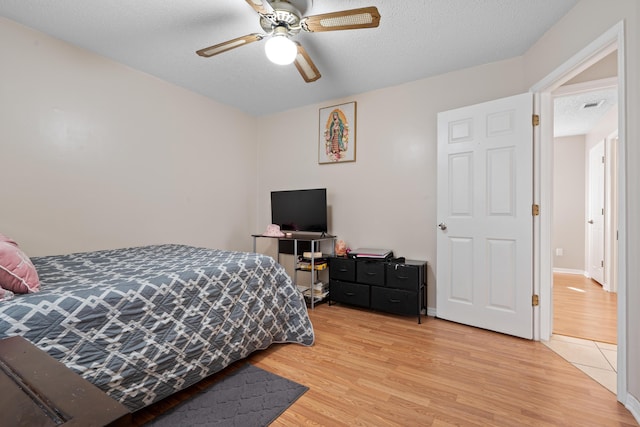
(318, 102, 356, 164)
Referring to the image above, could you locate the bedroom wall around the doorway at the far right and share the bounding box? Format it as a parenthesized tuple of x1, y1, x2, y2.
(524, 0, 640, 418)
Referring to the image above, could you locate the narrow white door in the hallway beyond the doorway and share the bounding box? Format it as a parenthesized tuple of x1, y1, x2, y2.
(587, 141, 604, 284)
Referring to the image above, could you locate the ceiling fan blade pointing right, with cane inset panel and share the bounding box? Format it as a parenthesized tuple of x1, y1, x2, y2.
(300, 6, 380, 32)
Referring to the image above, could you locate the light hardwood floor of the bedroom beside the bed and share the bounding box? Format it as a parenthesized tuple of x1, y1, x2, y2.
(134, 304, 638, 426)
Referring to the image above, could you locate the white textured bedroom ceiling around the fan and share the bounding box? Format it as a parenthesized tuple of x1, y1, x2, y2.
(0, 0, 577, 116)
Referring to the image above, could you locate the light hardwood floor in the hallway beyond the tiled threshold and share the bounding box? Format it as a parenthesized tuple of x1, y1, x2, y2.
(553, 273, 618, 344)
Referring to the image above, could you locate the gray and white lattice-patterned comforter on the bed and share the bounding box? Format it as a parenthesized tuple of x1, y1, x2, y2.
(0, 245, 314, 411)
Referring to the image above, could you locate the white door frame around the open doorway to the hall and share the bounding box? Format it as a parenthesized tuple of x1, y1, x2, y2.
(530, 21, 627, 403)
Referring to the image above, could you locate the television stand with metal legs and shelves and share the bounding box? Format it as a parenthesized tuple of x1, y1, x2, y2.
(251, 233, 336, 310)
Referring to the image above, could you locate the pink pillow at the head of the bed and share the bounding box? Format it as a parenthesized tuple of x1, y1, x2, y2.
(0, 234, 40, 294)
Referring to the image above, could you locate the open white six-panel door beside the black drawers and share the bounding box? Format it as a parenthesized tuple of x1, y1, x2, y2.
(436, 93, 533, 339)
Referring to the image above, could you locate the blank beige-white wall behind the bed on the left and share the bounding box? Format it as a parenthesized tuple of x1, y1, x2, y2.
(0, 18, 257, 256)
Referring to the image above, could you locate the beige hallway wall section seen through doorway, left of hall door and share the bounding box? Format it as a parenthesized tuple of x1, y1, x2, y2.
(552, 135, 586, 273)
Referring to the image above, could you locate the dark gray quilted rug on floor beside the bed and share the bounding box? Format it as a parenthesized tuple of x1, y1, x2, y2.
(145, 364, 309, 427)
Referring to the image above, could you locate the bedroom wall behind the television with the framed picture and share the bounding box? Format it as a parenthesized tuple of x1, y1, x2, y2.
(256, 58, 526, 308)
